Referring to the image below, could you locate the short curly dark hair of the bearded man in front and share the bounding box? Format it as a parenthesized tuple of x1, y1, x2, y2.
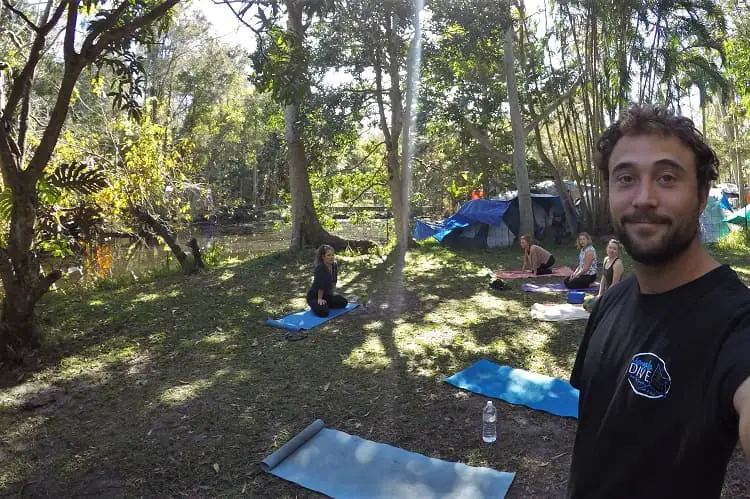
(595, 104, 719, 194)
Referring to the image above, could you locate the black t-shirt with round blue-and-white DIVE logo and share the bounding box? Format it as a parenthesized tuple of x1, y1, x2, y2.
(568, 266, 750, 499)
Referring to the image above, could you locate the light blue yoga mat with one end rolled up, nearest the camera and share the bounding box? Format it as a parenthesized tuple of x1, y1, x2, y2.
(261, 419, 515, 499)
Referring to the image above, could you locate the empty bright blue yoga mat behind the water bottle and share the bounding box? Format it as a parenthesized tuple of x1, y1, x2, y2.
(443, 360, 578, 418)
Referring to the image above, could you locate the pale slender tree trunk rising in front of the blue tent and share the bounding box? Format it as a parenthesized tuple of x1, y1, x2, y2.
(503, 24, 534, 237)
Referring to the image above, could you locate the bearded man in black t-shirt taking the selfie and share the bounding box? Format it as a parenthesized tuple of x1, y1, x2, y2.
(568, 106, 750, 498)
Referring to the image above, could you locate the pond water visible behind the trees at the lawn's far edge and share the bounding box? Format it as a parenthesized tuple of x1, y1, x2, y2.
(73, 220, 394, 287)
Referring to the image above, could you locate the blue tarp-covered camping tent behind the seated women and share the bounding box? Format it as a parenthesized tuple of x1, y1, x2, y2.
(414, 194, 577, 248)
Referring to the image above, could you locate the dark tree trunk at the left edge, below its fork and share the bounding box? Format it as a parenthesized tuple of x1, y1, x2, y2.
(0, 178, 62, 360)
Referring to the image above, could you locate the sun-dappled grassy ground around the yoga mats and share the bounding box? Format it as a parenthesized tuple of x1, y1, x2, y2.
(0, 244, 750, 498)
